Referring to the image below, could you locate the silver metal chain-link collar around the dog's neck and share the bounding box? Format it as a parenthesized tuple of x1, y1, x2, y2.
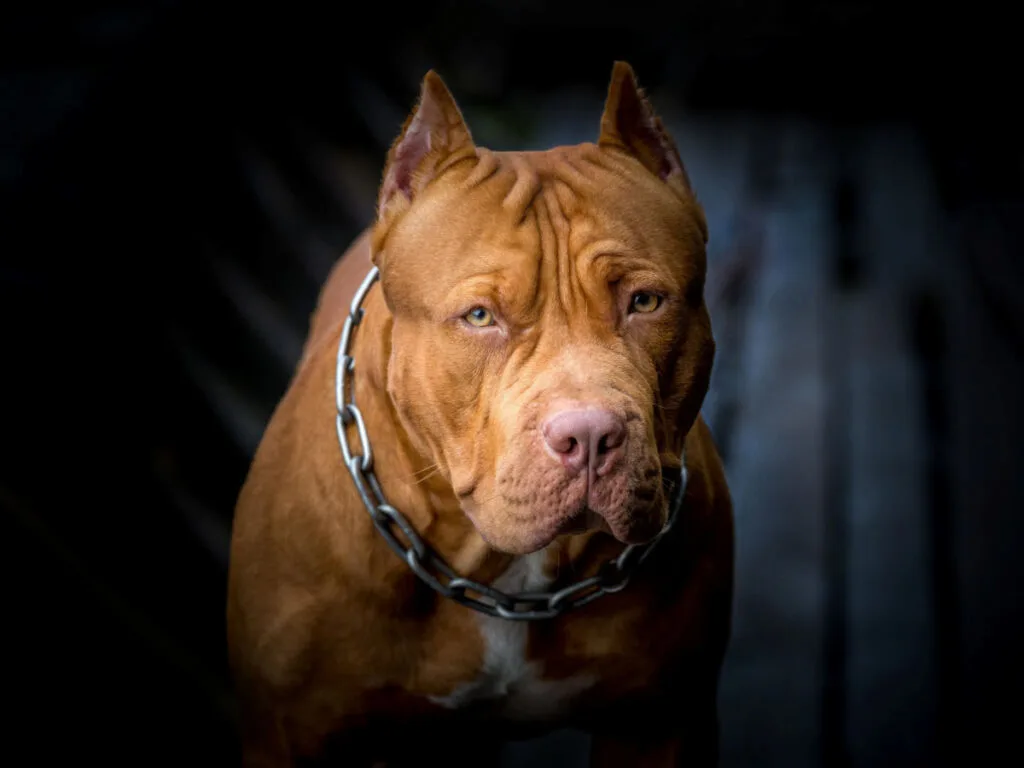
(335, 266, 687, 621)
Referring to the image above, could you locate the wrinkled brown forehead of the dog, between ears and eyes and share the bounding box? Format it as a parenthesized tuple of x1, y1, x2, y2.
(384, 144, 703, 298)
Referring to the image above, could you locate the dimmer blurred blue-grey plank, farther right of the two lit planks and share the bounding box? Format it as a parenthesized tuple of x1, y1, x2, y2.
(836, 129, 935, 768)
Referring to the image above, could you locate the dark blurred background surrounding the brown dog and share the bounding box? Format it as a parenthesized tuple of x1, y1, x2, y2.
(0, 0, 1024, 766)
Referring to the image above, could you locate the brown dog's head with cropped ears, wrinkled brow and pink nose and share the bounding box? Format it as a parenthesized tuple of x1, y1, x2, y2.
(373, 62, 714, 554)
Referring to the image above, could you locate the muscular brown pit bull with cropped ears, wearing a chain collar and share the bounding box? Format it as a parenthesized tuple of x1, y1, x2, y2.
(227, 62, 733, 766)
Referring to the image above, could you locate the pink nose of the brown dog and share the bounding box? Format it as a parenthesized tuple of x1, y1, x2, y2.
(543, 409, 626, 476)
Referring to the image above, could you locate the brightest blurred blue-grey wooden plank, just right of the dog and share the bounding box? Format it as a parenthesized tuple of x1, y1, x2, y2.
(720, 124, 834, 768)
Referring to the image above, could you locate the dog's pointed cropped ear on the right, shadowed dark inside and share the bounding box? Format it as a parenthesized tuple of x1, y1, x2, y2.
(597, 61, 692, 191)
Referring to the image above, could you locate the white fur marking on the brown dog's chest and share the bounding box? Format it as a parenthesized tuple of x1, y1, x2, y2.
(431, 551, 595, 719)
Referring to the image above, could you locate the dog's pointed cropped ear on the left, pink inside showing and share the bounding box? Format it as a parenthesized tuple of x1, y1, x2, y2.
(377, 70, 474, 219)
